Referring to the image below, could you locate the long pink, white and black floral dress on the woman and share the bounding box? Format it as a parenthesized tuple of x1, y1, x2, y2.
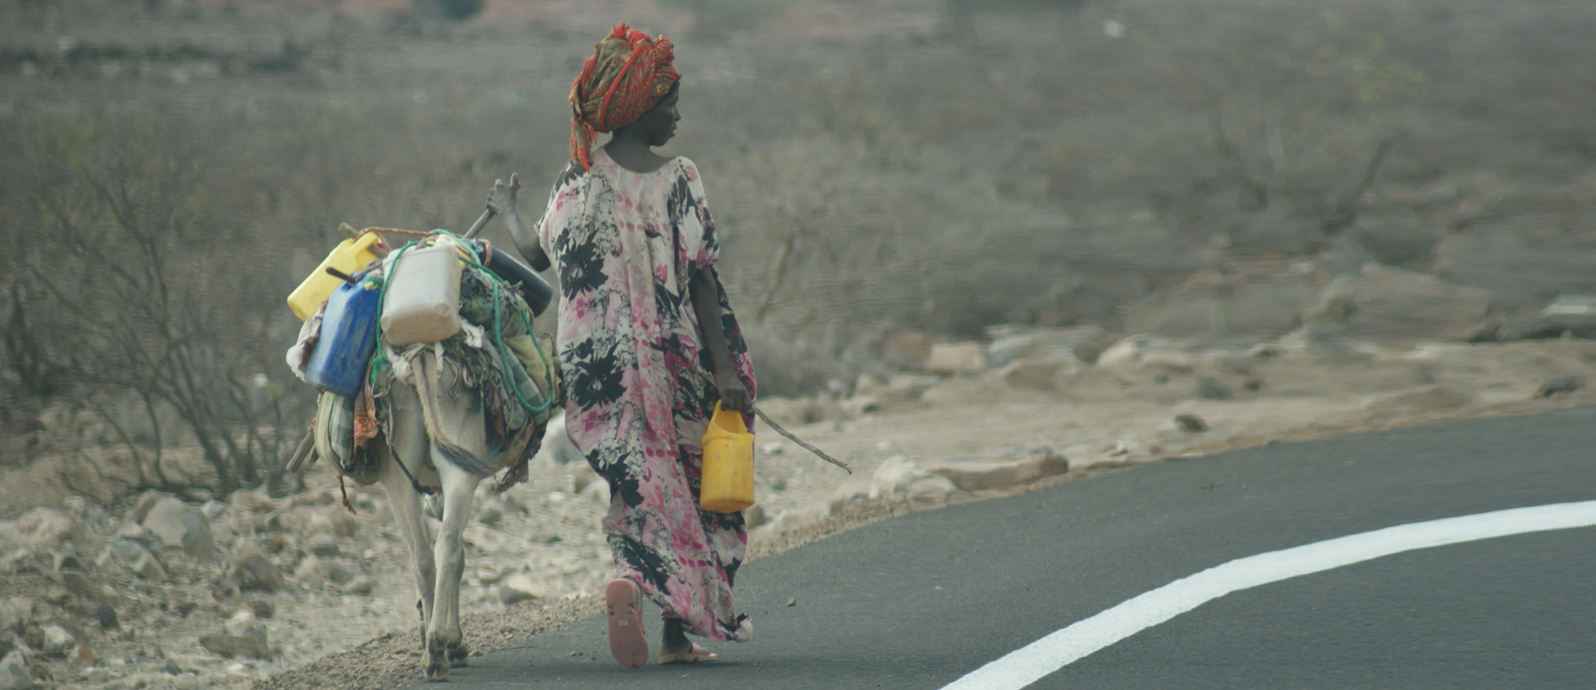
(538, 149, 755, 642)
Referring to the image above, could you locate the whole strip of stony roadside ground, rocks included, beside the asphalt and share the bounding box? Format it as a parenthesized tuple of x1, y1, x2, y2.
(0, 319, 1596, 688)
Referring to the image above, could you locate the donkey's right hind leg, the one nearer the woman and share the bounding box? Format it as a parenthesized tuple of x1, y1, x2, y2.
(426, 444, 482, 680)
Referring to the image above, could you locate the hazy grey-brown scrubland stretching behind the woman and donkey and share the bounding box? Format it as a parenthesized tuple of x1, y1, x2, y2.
(0, 0, 1596, 504)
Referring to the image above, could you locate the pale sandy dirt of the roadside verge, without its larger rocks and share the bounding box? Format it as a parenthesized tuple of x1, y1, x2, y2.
(0, 332, 1596, 688)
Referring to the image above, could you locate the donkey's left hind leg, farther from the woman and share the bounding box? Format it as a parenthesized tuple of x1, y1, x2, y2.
(378, 382, 437, 647)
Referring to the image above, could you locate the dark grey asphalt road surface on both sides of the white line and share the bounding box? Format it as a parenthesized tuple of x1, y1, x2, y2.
(418, 409, 1596, 690)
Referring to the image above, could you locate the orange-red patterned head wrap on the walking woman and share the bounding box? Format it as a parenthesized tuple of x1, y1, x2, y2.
(571, 24, 681, 169)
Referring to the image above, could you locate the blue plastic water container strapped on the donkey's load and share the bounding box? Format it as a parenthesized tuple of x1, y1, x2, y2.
(305, 276, 381, 396)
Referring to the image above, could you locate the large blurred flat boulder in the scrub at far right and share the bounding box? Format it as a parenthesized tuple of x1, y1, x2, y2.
(1302, 264, 1492, 340)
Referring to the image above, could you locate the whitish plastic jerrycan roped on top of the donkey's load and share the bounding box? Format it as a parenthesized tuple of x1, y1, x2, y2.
(381, 238, 461, 345)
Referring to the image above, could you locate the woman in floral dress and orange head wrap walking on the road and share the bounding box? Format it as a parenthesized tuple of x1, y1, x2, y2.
(488, 24, 755, 666)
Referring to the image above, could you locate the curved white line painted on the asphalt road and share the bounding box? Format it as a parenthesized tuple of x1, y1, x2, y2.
(943, 500, 1596, 690)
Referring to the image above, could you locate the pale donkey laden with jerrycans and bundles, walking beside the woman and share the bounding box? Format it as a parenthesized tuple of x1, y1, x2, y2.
(287, 214, 563, 680)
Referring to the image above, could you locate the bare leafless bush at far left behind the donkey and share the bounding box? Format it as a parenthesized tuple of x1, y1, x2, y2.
(10, 118, 294, 494)
